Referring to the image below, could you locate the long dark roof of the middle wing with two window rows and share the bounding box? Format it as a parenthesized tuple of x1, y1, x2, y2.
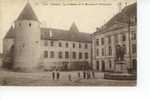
(41, 28, 92, 42)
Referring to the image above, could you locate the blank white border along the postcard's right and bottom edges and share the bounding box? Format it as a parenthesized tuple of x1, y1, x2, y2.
(0, 0, 150, 100)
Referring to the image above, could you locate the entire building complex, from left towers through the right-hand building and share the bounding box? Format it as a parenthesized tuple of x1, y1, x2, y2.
(3, 3, 137, 73)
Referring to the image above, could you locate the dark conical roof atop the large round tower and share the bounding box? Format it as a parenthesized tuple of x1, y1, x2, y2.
(17, 3, 38, 21)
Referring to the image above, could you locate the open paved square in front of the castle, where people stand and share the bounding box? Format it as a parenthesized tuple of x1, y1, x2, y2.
(0, 70, 136, 86)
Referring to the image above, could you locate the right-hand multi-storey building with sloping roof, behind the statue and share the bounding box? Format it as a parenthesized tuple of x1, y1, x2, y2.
(92, 3, 137, 72)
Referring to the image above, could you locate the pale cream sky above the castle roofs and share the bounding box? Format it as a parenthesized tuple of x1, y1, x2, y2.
(0, 0, 136, 52)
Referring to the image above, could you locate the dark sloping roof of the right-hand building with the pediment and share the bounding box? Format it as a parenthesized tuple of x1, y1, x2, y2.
(94, 3, 137, 34)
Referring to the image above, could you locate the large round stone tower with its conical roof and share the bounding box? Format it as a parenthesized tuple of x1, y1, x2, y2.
(14, 3, 40, 71)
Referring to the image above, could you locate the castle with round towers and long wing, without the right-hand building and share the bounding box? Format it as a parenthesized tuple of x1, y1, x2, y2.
(3, 3, 92, 71)
